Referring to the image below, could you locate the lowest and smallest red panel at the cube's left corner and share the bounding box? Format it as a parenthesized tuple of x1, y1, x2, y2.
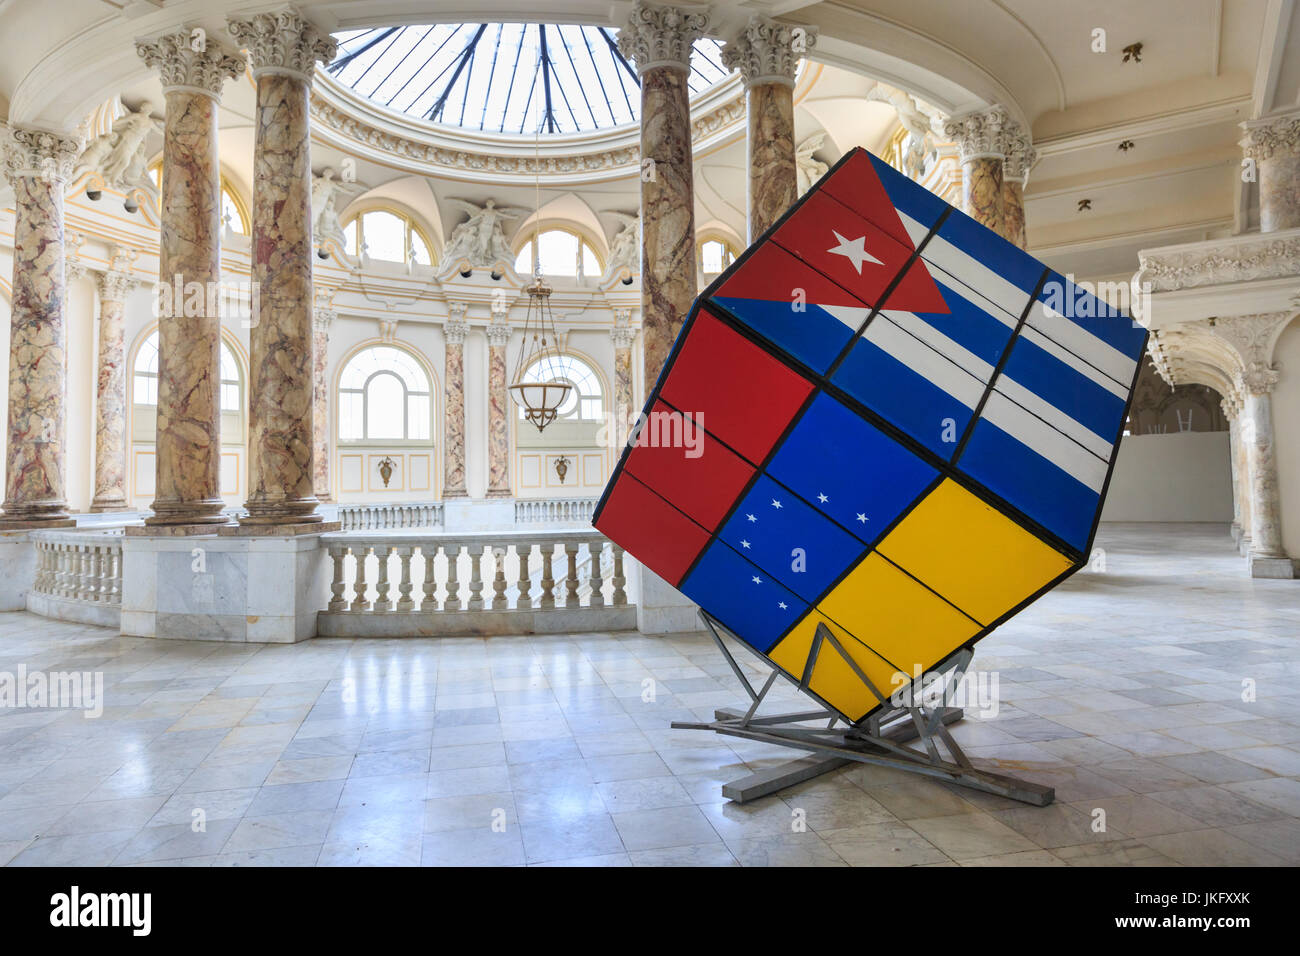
(595, 471, 710, 587)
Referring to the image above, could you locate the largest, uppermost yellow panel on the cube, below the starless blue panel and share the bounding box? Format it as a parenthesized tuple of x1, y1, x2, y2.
(878, 479, 1071, 624)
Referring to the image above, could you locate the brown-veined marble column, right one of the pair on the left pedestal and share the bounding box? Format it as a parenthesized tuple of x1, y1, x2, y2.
(226, 7, 338, 529)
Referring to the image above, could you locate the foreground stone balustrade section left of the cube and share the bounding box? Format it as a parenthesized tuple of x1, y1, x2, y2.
(317, 531, 636, 637)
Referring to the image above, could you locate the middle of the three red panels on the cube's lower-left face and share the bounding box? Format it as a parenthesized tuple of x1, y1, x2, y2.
(624, 402, 754, 531)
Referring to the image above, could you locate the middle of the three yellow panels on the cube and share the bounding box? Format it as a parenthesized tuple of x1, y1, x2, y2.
(819, 553, 980, 674)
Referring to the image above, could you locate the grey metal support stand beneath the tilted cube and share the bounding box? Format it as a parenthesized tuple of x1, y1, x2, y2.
(672, 611, 1056, 806)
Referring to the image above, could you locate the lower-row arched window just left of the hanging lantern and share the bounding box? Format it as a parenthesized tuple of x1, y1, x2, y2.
(338, 345, 433, 441)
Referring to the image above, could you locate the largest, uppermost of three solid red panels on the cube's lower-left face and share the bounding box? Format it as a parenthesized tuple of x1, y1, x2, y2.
(660, 308, 813, 464)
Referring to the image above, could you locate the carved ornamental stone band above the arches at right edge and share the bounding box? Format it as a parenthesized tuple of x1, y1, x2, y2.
(1135, 234, 1300, 293)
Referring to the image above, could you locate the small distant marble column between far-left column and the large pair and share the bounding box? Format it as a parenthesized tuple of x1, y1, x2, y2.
(90, 261, 135, 511)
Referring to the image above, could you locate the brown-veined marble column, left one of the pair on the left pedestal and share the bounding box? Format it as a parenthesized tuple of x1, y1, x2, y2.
(135, 31, 243, 529)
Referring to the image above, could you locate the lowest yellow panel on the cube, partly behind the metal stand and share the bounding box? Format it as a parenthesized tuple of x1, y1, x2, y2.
(768, 610, 907, 721)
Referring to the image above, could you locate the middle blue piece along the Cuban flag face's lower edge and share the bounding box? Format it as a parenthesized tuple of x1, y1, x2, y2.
(831, 338, 972, 460)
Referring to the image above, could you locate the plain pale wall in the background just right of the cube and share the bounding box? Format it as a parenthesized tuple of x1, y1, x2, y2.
(1101, 432, 1232, 523)
